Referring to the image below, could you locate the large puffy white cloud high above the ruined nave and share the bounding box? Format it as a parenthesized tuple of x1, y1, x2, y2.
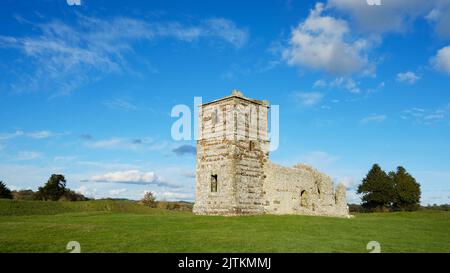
(283, 3, 373, 75)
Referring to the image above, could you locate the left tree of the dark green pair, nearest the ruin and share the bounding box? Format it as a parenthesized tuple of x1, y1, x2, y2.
(357, 164, 394, 211)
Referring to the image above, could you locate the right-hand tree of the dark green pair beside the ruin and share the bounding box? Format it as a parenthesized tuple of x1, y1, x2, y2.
(389, 166, 421, 211)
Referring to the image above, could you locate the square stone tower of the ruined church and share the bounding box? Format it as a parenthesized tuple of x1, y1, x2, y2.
(194, 90, 269, 215)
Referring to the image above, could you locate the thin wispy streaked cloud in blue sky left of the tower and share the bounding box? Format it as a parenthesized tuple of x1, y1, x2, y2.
(0, 14, 248, 97)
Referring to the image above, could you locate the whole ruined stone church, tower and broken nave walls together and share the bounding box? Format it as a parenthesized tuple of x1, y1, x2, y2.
(194, 90, 349, 217)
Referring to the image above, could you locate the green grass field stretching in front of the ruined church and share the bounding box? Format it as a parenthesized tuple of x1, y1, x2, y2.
(0, 200, 450, 252)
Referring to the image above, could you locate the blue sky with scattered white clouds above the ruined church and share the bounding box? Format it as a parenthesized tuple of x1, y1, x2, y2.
(0, 0, 450, 205)
